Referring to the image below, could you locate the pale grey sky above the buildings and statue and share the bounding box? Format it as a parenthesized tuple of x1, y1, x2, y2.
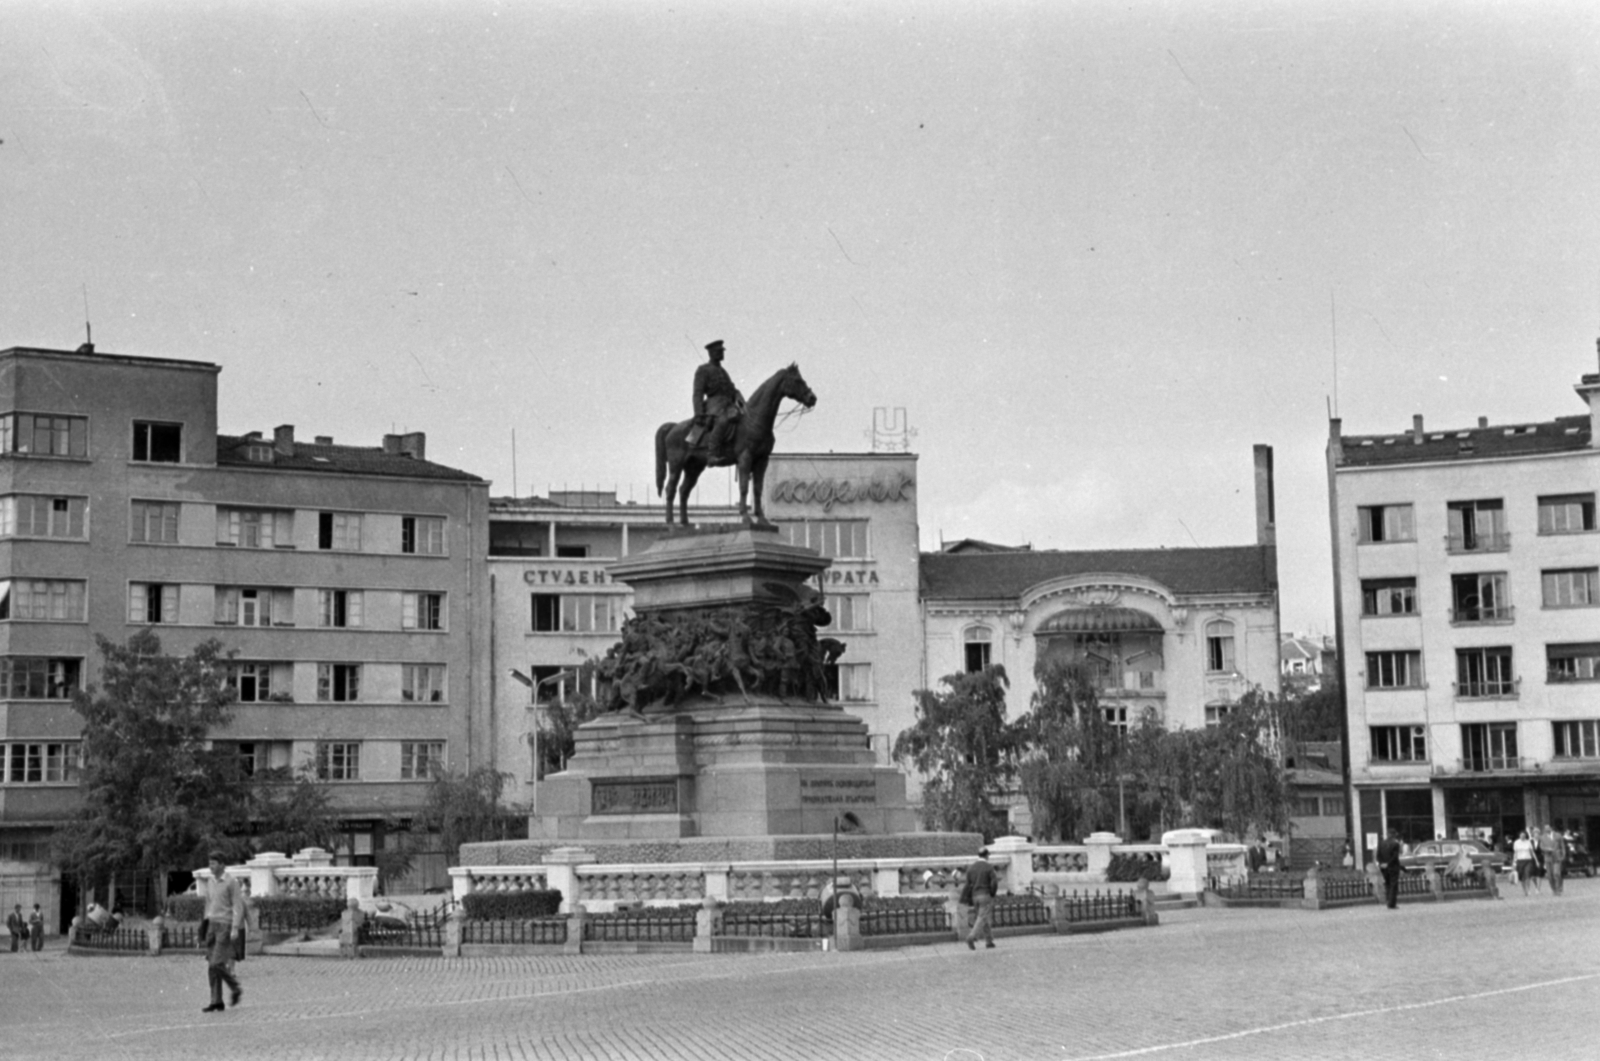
(0, 0, 1600, 632)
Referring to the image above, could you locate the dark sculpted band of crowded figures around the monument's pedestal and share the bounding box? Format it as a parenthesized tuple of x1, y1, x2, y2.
(597, 584, 845, 711)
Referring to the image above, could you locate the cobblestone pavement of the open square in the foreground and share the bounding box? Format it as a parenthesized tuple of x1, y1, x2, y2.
(0, 880, 1600, 1061)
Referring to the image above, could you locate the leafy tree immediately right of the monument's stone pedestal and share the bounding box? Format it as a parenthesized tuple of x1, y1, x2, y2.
(894, 664, 1022, 839)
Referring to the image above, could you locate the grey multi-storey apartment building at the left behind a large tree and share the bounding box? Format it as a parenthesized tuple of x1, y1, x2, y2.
(0, 344, 488, 921)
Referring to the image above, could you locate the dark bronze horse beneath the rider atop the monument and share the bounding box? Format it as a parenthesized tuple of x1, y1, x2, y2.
(656, 363, 816, 526)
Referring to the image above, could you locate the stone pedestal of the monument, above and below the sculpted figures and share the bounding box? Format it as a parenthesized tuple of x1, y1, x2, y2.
(530, 528, 917, 843)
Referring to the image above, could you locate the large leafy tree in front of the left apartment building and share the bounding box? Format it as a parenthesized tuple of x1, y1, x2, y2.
(53, 631, 248, 915)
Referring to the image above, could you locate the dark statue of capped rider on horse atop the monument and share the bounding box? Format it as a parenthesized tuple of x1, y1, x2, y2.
(656, 339, 816, 526)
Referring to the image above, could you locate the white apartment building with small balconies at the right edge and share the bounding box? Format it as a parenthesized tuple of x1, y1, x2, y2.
(1328, 352, 1600, 858)
